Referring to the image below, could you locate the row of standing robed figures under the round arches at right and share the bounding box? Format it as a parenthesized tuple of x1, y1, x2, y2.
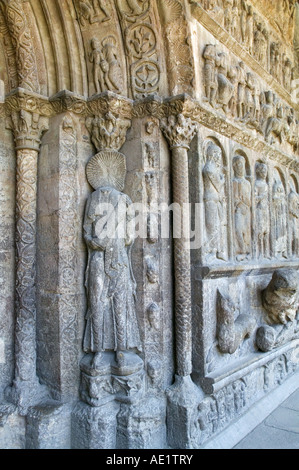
(203, 142, 299, 263)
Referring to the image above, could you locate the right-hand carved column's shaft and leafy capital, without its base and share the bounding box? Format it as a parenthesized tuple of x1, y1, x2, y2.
(161, 114, 197, 377)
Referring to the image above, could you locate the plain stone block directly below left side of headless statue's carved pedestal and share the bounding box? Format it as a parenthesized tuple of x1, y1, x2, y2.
(72, 402, 119, 449)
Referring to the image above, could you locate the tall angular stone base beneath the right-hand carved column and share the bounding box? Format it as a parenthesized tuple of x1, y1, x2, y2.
(167, 376, 204, 449)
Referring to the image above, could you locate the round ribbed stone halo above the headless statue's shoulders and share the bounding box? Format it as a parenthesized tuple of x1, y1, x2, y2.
(86, 150, 127, 191)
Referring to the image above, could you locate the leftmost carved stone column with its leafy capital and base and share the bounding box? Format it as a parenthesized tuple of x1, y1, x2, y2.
(7, 91, 47, 412)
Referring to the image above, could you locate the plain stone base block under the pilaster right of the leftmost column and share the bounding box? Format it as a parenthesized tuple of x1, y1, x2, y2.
(26, 403, 71, 449)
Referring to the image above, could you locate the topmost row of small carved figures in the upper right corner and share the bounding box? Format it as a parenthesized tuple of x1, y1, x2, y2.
(200, 0, 296, 93)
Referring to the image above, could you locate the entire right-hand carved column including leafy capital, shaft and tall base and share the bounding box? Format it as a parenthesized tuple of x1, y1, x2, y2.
(161, 110, 204, 448)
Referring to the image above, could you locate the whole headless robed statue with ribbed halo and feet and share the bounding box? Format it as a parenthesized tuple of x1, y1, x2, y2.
(83, 151, 141, 369)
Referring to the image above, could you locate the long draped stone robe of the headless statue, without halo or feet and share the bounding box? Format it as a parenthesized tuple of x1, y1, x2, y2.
(83, 187, 141, 352)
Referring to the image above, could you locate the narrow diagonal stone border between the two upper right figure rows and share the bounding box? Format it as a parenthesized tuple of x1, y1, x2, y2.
(190, 1, 299, 110)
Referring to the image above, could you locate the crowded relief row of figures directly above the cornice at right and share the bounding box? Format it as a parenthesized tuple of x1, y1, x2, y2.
(203, 44, 299, 152)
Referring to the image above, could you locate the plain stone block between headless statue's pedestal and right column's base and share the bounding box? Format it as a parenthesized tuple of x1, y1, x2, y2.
(117, 398, 166, 449)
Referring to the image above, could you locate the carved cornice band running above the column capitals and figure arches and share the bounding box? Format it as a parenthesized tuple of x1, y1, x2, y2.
(0, 88, 299, 172)
